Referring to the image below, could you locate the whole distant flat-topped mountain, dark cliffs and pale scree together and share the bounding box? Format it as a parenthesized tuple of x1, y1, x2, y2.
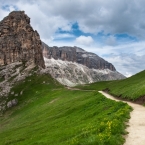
(42, 43, 125, 86)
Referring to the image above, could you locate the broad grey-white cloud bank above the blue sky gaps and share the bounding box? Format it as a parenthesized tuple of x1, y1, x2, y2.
(0, 0, 145, 39)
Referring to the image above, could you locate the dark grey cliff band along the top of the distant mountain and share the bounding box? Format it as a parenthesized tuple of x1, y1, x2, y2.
(42, 43, 116, 71)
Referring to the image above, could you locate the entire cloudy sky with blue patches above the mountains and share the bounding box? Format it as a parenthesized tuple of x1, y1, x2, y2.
(0, 0, 145, 77)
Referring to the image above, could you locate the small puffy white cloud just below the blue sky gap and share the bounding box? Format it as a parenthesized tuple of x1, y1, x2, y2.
(76, 35, 93, 46)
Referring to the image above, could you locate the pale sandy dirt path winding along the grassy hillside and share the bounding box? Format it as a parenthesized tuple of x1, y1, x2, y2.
(99, 91, 145, 145)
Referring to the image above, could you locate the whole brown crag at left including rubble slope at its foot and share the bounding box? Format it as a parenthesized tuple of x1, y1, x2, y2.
(0, 11, 45, 115)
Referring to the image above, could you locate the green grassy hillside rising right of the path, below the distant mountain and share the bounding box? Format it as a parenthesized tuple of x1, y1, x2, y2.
(79, 71, 145, 101)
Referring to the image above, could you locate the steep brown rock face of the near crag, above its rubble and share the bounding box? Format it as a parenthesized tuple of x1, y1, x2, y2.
(0, 11, 45, 68)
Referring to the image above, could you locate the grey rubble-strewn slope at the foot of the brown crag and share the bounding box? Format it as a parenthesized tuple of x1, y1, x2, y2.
(0, 62, 36, 113)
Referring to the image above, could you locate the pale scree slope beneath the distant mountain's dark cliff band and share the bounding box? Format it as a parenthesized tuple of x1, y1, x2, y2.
(43, 57, 124, 86)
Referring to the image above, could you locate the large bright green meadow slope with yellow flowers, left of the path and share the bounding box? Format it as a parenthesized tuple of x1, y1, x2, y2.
(0, 75, 131, 145)
